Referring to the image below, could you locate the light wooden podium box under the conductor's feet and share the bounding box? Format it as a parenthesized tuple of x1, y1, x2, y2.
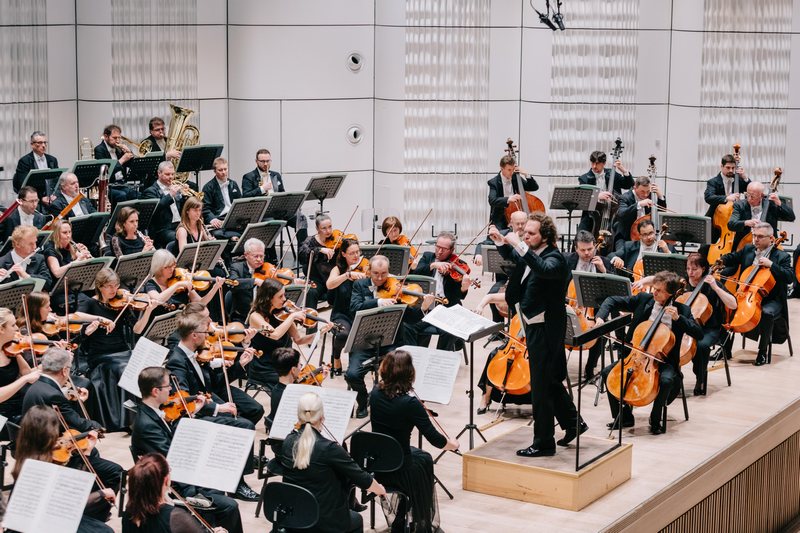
(462, 426, 633, 511)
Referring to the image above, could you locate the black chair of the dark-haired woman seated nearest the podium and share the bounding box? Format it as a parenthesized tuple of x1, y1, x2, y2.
(350, 431, 413, 533)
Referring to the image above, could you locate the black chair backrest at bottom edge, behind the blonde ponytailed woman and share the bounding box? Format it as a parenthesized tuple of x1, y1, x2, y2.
(264, 481, 319, 533)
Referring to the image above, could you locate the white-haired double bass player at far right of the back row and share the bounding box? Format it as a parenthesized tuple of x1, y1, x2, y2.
(728, 181, 795, 250)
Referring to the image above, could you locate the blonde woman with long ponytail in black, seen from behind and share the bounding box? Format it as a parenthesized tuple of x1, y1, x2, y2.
(281, 392, 386, 533)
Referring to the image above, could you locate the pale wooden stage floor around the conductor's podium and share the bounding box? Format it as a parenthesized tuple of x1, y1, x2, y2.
(43, 266, 800, 533)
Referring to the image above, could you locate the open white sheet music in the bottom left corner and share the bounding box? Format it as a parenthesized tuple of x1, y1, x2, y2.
(3, 459, 94, 533)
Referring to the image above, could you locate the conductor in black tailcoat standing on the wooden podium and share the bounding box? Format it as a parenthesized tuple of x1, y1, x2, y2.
(489, 213, 589, 457)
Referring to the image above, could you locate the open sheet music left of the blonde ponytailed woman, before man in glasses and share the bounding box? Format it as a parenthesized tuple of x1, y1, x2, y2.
(167, 418, 256, 492)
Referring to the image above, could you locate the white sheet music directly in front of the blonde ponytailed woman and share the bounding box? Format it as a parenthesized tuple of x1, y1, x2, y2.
(269, 385, 356, 443)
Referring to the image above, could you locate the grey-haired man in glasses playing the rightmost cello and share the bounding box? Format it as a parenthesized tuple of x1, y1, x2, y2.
(722, 222, 794, 366)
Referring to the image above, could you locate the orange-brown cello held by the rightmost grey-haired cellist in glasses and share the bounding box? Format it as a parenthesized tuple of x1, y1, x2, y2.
(725, 231, 786, 333)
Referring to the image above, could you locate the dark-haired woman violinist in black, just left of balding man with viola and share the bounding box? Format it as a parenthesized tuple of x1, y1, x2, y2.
(326, 239, 367, 376)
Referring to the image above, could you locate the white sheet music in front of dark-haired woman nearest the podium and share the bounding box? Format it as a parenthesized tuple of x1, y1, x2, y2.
(398, 346, 461, 404)
